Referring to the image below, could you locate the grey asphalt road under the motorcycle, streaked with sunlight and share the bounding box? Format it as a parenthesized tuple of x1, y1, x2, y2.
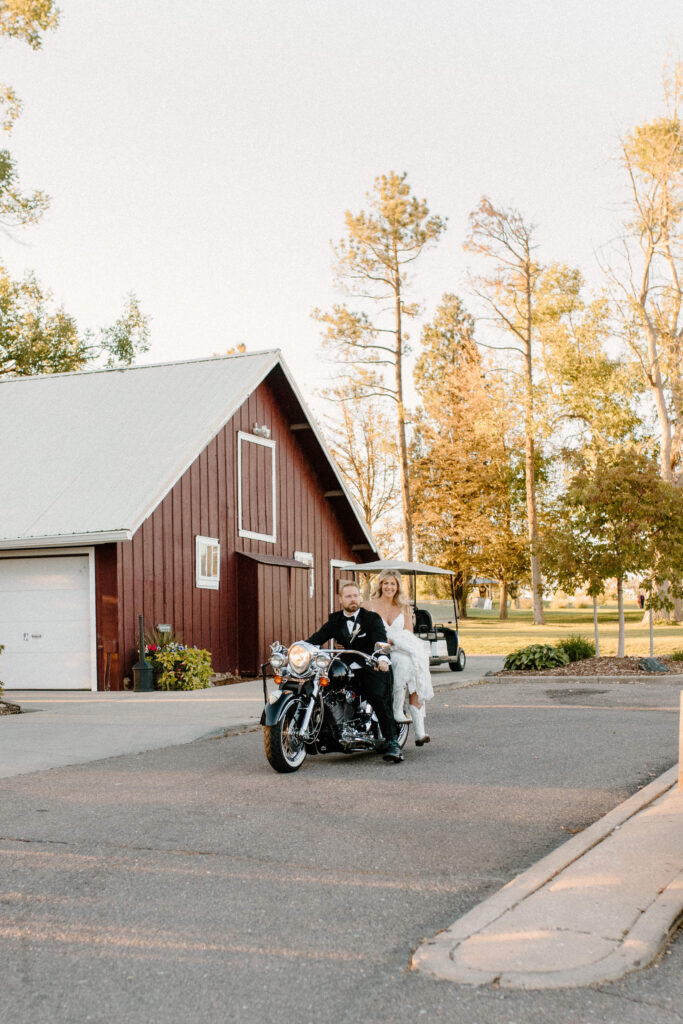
(0, 680, 683, 1024)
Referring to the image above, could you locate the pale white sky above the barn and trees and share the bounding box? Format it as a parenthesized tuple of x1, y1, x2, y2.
(0, 0, 683, 411)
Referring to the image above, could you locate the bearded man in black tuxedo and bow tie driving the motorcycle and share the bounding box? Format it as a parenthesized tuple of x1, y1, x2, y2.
(308, 583, 403, 764)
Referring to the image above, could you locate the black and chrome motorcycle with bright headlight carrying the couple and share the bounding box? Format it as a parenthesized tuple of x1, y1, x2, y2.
(261, 640, 409, 772)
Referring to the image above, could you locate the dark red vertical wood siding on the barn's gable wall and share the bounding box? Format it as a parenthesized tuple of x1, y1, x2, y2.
(107, 371, 371, 688)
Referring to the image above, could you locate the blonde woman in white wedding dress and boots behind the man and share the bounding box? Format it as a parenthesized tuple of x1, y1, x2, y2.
(366, 569, 434, 746)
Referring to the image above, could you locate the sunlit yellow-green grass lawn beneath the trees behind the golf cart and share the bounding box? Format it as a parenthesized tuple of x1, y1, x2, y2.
(420, 601, 683, 655)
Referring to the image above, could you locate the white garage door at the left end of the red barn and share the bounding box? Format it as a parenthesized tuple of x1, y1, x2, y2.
(0, 555, 92, 690)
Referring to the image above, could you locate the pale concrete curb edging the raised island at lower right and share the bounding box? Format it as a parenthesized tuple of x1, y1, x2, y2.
(411, 766, 683, 989)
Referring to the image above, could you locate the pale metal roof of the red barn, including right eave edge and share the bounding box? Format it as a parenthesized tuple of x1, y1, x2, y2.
(0, 349, 375, 550)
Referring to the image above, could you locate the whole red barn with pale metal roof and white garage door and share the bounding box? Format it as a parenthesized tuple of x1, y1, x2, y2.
(0, 351, 377, 689)
